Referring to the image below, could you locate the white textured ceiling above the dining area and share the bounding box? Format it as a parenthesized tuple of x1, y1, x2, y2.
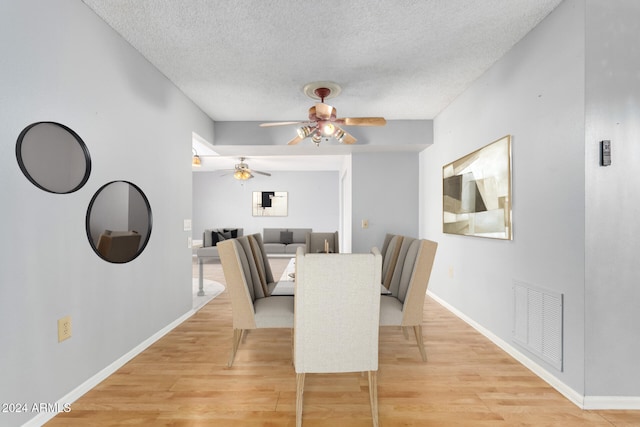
(83, 0, 561, 169)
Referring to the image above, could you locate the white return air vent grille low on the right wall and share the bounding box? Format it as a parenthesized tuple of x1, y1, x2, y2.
(513, 282, 563, 371)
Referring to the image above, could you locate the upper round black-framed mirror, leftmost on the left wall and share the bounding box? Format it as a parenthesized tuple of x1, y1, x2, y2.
(16, 122, 91, 194)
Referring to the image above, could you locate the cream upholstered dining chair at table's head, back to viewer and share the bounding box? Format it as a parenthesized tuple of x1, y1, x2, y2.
(294, 248, 382, 427)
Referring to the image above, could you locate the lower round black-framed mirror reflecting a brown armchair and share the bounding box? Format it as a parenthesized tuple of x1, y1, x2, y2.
(86, 181, 152, 263)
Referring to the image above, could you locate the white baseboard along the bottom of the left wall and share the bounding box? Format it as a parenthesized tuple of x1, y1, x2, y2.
(22, 309, 196, 427)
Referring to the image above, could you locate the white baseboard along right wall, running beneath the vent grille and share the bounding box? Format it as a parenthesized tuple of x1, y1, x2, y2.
(427, 291, 585, 409)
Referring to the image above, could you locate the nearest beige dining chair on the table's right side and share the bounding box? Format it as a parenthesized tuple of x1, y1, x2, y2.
(380, 237, 438, 362)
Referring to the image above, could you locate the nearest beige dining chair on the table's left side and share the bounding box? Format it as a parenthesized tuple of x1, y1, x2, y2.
(217, 236, 293, 367)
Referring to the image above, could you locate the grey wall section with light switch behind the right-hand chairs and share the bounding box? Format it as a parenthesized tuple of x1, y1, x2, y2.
(351, 151, 420, 253)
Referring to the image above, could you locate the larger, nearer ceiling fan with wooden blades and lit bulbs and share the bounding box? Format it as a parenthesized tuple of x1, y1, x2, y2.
(260, 85, 387, 146)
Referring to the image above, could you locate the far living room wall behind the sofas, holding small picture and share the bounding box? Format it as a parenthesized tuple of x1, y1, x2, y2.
(193, 171, 340, 239)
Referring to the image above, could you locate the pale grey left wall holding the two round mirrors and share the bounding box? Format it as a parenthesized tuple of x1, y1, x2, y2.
(0, 0, 213, 426)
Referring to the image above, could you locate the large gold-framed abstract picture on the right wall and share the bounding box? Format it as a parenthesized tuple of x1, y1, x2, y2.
(442, 135, 513, 240)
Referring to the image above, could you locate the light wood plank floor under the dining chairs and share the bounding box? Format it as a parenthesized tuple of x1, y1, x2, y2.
(47, 259, 640, 427)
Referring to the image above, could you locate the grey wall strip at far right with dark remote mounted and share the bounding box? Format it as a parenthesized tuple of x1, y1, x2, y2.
(585, 0, 640, 405)
